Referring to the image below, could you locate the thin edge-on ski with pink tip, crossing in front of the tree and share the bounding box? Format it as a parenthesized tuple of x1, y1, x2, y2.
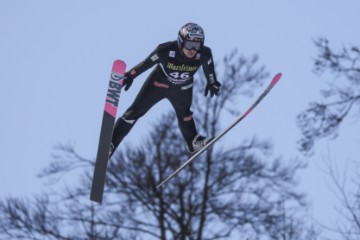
(156, 73, 282, 188)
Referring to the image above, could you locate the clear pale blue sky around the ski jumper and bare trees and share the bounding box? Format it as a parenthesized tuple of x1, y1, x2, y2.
(0, 0, 360, 238)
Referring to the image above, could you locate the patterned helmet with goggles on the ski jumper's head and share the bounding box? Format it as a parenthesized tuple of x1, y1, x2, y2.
(177, 23, 205, 51)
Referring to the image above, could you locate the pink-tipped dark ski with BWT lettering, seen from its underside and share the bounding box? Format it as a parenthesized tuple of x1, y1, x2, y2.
(90, 60, 126, 204)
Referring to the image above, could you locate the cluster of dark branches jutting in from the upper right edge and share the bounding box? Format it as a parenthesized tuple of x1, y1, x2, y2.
(297, 38, 360, 154)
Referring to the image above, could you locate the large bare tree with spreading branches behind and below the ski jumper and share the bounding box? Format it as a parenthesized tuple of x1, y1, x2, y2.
(0, 51, 310, 240)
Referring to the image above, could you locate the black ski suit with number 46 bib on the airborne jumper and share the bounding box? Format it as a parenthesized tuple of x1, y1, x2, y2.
(112, 41, 217, 152)
